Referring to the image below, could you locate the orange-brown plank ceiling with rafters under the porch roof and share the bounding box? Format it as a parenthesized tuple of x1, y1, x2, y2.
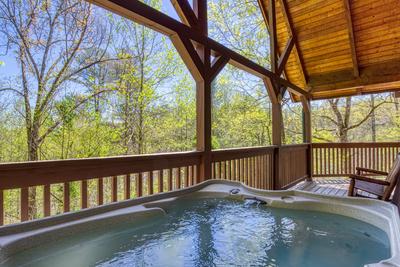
(262, 0, 400, 99)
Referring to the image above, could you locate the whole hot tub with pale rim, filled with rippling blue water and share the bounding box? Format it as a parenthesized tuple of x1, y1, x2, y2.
(0, 180, 400, 267)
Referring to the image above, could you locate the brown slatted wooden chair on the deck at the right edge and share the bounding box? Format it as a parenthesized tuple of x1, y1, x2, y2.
(348, 154, 400, 201)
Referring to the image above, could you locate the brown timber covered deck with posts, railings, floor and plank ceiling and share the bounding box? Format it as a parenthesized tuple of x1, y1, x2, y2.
(0, 0, 400, 224)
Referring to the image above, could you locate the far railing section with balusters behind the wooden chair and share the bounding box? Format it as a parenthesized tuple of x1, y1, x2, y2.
(312, 142, 400, 177)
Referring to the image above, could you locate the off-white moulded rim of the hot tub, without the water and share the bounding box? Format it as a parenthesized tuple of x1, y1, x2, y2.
(0, 180, 400, 267)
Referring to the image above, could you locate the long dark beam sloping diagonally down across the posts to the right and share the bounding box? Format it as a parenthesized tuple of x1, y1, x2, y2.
(91, 0, 308, 95)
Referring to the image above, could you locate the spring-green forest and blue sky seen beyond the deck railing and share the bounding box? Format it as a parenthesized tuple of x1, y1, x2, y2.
(0, 0, 400, 223)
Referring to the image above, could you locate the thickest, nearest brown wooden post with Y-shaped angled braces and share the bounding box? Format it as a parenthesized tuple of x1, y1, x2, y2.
(171, 0, 230, 183)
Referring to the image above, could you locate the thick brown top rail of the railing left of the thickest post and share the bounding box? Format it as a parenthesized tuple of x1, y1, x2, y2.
(0, 151, 201, 189)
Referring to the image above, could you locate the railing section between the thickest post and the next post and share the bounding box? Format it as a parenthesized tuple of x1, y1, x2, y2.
(211, 146, 277, 189)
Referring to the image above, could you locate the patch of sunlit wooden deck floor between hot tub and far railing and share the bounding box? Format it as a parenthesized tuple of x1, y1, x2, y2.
(291, 178, 374, 197)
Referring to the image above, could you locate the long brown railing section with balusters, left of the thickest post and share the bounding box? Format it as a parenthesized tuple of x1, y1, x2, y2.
(0, 152, 201, 224)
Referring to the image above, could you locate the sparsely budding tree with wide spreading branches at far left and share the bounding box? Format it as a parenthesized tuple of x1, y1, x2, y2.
(0, 0, 114, 219)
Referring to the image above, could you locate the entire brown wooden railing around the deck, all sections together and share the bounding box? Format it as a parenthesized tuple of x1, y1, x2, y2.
(11, 142, 400, 224)
